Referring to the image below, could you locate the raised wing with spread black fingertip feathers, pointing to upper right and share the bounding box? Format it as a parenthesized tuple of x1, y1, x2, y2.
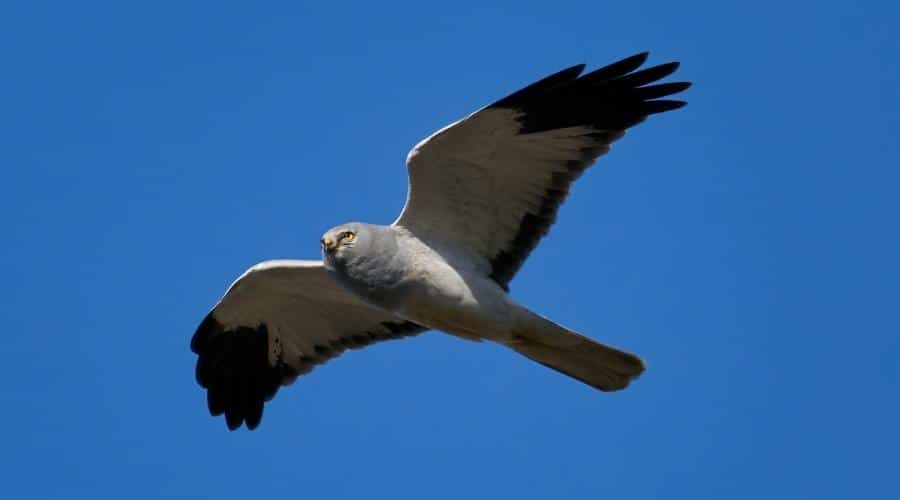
(394, 53, 690, 288)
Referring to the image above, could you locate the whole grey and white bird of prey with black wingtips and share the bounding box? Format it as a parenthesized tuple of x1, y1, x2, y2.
(191, 53, 690, 430)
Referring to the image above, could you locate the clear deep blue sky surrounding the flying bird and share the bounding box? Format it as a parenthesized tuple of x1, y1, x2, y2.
(0, 1, 900, 500)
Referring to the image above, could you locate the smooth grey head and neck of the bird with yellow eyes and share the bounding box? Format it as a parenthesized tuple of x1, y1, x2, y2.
(321, 222, 407, 307)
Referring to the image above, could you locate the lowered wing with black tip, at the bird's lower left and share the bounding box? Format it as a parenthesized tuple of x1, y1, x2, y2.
(191, 260, 426, 430)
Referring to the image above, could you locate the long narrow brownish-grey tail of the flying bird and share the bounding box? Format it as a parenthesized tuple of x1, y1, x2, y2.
(505, 313, 644, 391)
